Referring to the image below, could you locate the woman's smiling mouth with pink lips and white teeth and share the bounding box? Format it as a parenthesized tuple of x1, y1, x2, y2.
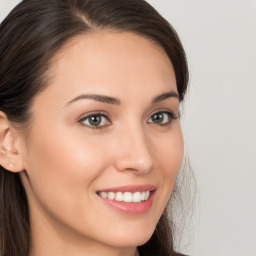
(97, 185, 156, 214)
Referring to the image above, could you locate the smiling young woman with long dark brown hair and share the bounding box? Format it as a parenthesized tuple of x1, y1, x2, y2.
(0, 0, 188, 256)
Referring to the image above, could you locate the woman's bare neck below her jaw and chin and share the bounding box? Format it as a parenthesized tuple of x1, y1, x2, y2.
(29, 207, 137, 256)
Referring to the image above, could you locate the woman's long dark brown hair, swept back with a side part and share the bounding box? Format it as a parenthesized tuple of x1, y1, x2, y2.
(0, 0, 188, 256)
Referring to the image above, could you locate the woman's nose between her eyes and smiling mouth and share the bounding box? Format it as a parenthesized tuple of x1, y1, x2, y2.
(114, 123, 154, 174)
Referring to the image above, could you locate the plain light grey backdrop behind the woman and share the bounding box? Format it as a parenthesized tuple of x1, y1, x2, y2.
(0, 0, 256, 256)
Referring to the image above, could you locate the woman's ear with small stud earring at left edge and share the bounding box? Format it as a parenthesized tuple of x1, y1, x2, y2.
(0, 111, 24, 173)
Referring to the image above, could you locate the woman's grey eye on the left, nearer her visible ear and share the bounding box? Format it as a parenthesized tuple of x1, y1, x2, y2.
(79, 113, 110, 129)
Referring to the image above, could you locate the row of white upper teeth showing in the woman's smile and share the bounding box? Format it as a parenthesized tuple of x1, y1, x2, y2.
(99, 191, 150, 203)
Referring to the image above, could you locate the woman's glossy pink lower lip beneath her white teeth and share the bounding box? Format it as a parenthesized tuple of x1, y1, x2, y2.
(99, 191, 155, 214)
